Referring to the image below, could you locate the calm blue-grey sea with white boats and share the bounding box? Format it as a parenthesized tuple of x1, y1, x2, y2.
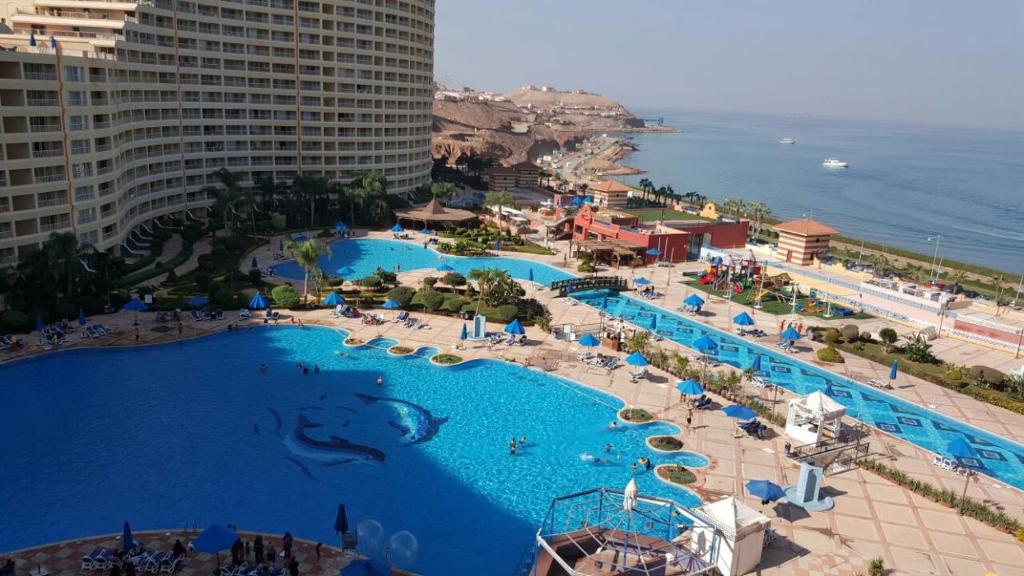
(621, 110, 1024, 274)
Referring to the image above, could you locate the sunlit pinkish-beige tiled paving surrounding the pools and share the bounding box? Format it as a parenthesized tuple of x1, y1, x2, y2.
(0, 233, 1024, 576)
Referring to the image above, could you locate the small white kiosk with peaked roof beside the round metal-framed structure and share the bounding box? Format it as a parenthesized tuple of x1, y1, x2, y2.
(690, 496, 771, 576)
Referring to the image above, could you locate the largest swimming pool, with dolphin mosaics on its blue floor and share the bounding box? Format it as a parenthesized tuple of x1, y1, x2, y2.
(0, 327, 707, 575)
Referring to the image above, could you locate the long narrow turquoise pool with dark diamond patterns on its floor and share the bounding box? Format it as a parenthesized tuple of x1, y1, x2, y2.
(573, 290, 1024, 489)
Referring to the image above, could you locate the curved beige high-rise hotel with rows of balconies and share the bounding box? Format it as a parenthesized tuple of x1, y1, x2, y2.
(0, 0, 434, 265)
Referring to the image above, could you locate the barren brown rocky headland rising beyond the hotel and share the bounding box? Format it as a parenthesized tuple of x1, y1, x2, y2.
(433, 89, 644, 164)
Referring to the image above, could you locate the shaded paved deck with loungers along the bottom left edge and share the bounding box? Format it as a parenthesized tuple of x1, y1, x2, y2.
(0, 529, 355, 576)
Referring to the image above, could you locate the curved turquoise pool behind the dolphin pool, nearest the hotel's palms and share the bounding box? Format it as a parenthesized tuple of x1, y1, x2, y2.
(273, 238, 572, 284)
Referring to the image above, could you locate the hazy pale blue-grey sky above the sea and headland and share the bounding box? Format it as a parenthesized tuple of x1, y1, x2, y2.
(435, 0, 1024, 128)
